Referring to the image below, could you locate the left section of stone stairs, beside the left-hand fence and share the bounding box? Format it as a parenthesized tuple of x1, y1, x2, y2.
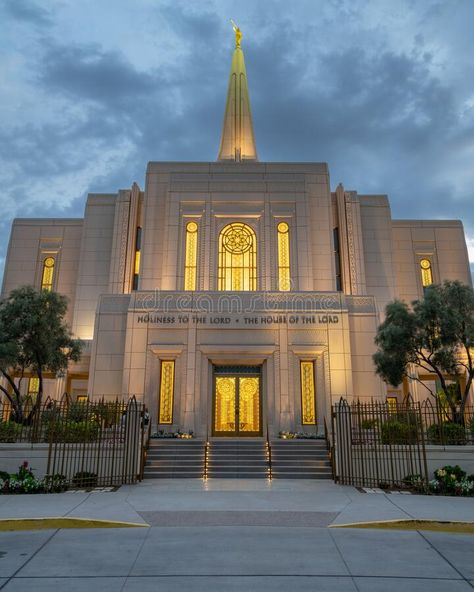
(143, 438, 204, 479)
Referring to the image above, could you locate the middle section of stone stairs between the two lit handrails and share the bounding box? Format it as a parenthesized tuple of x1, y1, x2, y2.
(207, 438, 269, 479)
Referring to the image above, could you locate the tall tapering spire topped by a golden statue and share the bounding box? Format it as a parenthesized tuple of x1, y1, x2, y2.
(218, 21, 258, 162)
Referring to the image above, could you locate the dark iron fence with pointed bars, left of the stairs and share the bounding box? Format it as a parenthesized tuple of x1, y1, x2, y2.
(0, 396, 149, 488)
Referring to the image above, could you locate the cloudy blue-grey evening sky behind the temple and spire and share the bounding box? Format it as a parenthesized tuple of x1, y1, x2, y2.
(0, 0, 474, 277)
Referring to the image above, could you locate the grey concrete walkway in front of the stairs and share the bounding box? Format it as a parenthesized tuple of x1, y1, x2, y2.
(0, 480, 474, 592)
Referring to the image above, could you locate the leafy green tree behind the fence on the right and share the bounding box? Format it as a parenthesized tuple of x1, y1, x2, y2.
(373, 281, 474, 423)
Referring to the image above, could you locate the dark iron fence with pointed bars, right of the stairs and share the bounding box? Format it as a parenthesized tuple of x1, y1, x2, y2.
(330, 399, 474, 487)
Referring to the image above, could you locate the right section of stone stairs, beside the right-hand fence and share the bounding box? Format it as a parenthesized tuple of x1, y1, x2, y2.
(271, 439, 332, 479)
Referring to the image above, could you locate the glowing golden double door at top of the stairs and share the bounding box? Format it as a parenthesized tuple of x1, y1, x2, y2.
(212, 372, 262, 437)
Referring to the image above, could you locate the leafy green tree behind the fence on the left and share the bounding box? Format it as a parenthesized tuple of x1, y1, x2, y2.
(0, 286, 82, 422)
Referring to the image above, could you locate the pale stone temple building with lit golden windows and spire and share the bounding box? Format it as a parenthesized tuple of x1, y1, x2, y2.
(2, 29, 471, 437)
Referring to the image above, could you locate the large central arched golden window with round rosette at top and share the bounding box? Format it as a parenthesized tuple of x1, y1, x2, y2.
(218, 222, 257, 291)
